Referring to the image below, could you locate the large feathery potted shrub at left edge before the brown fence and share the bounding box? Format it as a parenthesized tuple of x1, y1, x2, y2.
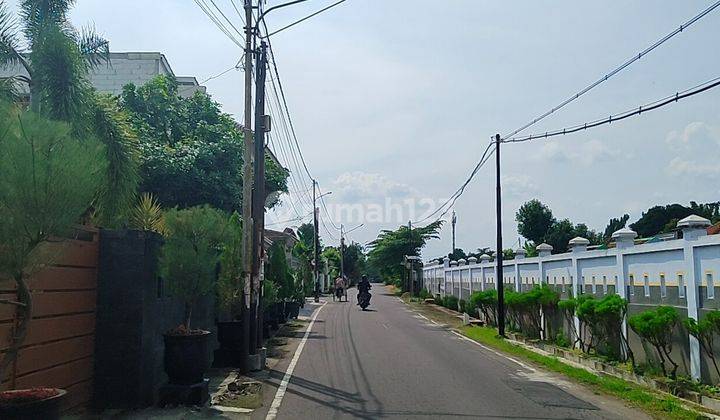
(0, 106, 106, 419)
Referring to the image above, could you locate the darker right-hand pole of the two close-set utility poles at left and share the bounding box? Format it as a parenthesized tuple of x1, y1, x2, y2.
(250, 41, 270, 352)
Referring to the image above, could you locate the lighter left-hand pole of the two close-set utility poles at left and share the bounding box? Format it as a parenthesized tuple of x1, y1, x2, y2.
(240, 0, 254, 373)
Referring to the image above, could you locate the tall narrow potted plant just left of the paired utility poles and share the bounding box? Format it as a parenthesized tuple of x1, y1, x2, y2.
(213, 213, 244, 367)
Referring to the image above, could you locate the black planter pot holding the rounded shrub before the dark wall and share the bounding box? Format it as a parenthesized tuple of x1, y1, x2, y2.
(163, 331, 212, 385)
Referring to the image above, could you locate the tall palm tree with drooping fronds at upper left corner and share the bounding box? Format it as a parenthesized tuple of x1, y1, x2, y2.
(0, 0, 138, 225)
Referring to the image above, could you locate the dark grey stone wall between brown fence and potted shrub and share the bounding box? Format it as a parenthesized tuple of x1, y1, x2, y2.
(93, 230, 217, 408)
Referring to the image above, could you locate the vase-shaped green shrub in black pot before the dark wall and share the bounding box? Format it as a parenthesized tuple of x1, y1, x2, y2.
(160, 206, 227, 385)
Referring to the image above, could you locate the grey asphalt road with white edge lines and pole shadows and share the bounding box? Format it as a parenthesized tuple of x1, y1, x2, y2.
(266, 285, 647, 419)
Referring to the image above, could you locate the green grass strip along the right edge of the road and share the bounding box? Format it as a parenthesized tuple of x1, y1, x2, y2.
(460, 326, 702, 419)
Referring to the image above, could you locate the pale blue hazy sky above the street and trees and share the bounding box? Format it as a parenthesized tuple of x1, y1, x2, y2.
(60, 0, 720, 258)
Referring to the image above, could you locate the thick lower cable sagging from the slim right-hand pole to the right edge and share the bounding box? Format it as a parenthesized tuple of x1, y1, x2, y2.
(501, 77, 720, 143)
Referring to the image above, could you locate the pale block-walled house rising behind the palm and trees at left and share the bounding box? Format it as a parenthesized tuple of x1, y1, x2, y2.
(0, 52, 206, 98)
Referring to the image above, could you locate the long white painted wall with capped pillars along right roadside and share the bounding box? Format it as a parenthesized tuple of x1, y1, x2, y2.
(423, 216, 720, 378)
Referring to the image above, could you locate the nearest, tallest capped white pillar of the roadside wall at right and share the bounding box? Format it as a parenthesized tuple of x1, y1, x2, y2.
(677, 214, 710, 379)
